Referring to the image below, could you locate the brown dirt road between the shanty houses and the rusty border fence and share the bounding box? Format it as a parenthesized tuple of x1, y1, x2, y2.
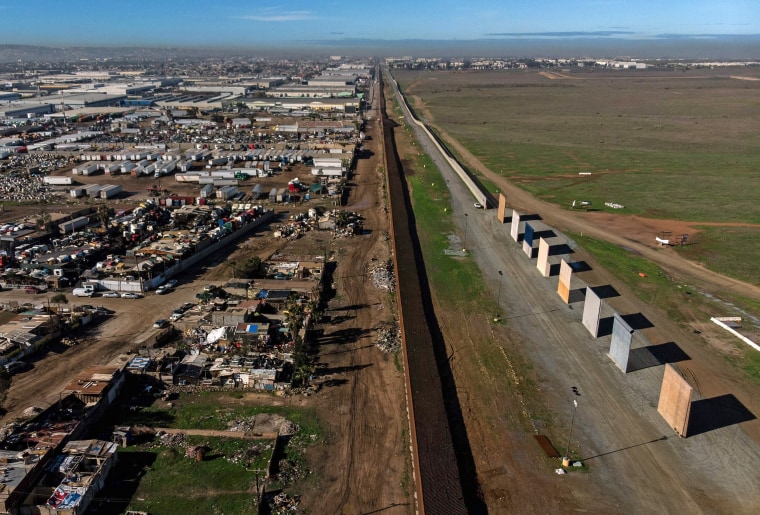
(302, 76, 414, 515)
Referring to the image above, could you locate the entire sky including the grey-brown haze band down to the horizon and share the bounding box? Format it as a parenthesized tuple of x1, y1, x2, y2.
(0, 0, 760, 59)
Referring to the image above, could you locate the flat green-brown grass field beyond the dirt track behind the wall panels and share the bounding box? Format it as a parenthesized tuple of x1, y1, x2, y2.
(395, 67, 760, 285)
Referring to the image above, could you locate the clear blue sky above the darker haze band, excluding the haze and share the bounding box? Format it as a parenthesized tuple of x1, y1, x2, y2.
(0, 0, 760, 47)
